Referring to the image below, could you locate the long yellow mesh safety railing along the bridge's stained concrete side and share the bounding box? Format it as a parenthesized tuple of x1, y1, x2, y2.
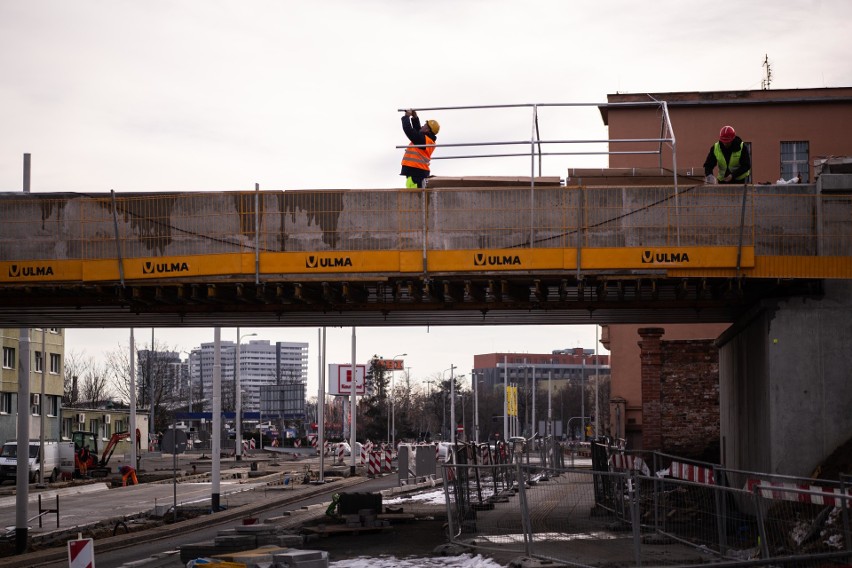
(5, 185, 852, 280)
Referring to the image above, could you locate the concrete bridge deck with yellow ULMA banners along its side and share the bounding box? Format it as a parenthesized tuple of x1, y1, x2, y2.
(0, 180, 852, 327)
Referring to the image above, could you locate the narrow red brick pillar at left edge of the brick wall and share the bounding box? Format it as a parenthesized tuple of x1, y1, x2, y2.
(639, 327, 665, 450)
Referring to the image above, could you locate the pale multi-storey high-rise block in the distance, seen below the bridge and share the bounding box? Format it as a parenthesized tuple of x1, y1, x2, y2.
(189, 339, 308, 412)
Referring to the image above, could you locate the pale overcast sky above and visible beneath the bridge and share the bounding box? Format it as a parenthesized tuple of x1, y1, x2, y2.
(0, 0, 852, 394)
